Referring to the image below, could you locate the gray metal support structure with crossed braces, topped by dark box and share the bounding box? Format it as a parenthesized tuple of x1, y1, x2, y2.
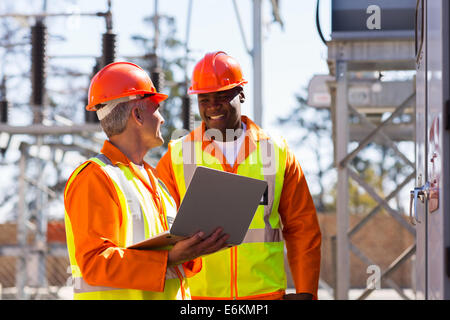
(316, 0, 415, 299)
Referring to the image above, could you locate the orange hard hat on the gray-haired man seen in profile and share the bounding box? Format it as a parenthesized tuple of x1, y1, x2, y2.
(86, 62, 168, 111)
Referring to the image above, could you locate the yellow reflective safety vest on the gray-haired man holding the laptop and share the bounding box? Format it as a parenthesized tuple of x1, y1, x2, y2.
(65, 154, 190, 300)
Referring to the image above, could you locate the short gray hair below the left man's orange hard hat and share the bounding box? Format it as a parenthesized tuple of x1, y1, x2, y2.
(100, 99, 147, 138)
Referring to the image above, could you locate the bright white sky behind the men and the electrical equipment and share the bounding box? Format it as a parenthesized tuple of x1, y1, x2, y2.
(0, 0, 331, 195)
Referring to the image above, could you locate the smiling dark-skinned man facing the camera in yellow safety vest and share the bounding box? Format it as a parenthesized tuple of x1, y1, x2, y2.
(157, 51, 321, 299)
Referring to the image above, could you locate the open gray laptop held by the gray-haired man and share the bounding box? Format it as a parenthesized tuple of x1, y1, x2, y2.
(128, 166, 267, 249)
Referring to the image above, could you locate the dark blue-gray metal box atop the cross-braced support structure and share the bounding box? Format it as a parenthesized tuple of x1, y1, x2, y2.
(331, 0, 417, 40)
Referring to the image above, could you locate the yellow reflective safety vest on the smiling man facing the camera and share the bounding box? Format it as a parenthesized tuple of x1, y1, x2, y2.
(170, 137, 286, 299)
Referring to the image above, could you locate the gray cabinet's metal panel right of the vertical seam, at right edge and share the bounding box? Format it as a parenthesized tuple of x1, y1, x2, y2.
(426, 1, 449, 299)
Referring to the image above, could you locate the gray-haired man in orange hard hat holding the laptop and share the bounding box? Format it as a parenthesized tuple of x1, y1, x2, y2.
(64, 62, 228, 299)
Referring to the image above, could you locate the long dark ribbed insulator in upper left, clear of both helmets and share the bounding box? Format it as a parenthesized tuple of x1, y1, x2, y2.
(31, 20, 47, 122)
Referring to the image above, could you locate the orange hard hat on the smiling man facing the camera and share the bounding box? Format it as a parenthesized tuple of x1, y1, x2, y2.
(188, 51, 247, 94)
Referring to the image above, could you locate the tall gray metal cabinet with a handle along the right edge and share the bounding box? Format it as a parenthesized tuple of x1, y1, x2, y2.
(410, 0, 450, 299)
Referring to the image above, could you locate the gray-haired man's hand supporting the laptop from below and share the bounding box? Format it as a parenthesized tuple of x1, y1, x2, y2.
(167, 228, 230, 266)
